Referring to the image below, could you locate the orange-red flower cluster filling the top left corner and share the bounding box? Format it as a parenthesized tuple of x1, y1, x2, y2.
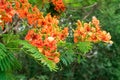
(0, 0, 43, 27)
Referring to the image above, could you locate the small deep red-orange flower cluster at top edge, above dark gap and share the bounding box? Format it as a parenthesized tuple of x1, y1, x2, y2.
(51, 0, 66, 13)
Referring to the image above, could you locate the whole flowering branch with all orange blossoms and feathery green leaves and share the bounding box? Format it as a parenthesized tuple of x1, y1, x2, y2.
(0, 0, 113, 80)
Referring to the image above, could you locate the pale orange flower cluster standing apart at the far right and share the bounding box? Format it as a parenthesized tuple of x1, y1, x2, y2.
(74, 17, 113, 43)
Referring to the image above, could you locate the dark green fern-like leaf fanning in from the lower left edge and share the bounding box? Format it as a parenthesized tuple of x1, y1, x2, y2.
(0, 43, 20, 71)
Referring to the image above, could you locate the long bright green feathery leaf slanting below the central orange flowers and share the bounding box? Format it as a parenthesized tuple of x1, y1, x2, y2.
(17, 40, 57, 71)
